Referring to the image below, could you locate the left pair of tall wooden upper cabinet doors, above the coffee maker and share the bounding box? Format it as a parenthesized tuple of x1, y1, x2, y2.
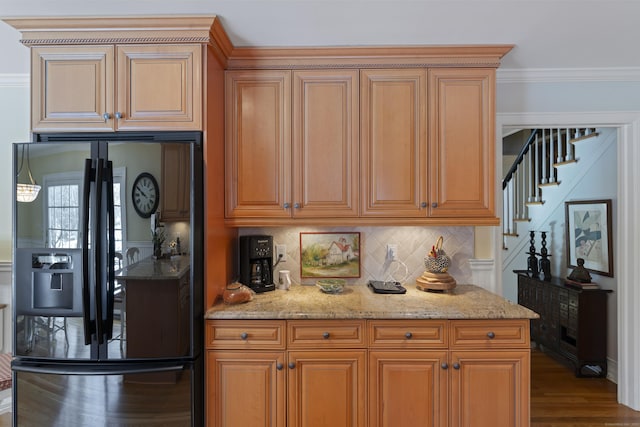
(226, 70, 359, 218)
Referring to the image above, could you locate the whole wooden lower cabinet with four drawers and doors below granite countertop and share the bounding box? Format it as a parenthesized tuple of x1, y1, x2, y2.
(206, 319, 530, 427)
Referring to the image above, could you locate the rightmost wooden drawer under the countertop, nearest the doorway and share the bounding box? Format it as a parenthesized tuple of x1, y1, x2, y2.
(451, 319, 529, 348)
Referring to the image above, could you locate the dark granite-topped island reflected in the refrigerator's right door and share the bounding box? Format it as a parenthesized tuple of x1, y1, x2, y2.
(116, 256, 190, 382)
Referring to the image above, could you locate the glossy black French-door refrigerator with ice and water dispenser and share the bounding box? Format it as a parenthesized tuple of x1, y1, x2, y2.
(12, 132, 204, 427)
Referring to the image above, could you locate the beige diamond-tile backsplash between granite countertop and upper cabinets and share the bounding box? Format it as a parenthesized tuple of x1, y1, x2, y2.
(239, 227, 474, 284)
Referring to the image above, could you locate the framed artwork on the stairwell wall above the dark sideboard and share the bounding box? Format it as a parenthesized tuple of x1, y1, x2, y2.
(565, 199, 613, 277)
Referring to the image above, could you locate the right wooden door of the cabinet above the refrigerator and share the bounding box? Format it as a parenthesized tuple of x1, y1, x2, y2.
(115, 44, 202, 130)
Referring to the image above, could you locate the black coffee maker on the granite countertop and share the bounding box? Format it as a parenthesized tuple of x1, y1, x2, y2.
(240, 235, 276, 293)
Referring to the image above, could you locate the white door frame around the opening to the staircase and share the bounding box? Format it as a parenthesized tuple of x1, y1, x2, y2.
(493, 112, 640, 411)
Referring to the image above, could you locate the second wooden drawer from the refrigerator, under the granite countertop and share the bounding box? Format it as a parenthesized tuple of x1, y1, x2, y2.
(287, 320, 366, 349)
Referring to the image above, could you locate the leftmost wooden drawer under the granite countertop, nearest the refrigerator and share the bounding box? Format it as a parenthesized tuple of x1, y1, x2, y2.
(206, 320, 285, 349)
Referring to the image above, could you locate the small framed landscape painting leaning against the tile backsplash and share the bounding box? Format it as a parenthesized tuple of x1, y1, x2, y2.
(300, 232, 361, 279)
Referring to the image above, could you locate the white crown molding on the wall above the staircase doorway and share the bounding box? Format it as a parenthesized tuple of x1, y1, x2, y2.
(496, 67, 640, 83)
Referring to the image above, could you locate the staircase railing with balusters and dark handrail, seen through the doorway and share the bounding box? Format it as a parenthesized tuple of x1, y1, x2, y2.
(502, 128, 599, 250)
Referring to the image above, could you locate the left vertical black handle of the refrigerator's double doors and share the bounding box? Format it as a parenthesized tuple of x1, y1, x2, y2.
(81, 159, 94, 345)
